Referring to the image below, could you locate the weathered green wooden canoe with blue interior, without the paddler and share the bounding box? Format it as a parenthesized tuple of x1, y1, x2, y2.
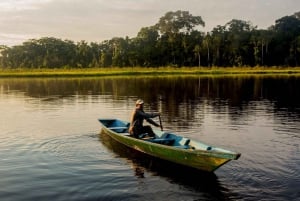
(99, 119, 241, 172)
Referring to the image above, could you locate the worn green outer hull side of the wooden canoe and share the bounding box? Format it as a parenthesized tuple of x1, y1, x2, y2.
(99, 119, 240, 172)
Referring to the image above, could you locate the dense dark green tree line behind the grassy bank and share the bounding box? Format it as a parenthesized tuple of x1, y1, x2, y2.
(0, 10, 300, 68)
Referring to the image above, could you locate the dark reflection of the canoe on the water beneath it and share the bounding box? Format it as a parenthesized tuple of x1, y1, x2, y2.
(99, 132, 230, 200)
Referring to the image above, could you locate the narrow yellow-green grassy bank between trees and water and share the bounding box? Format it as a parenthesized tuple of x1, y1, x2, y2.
(0, 67, 300, 77)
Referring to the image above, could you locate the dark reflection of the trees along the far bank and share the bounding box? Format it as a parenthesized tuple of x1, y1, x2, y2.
(0, 76, 300, 123)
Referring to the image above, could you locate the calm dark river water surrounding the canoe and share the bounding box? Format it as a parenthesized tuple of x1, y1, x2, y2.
(0, 76, 300, 201)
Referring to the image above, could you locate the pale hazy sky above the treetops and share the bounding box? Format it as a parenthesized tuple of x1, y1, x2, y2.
(0, 0, 300, 46)
